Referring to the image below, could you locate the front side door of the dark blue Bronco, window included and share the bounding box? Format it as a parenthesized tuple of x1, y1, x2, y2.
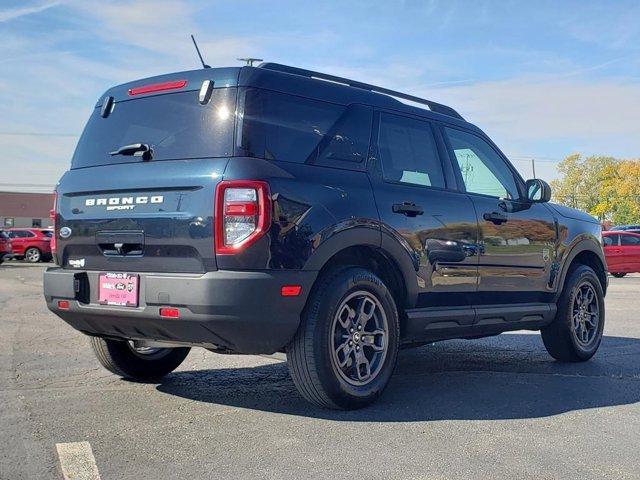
(443, 126, 558, 305)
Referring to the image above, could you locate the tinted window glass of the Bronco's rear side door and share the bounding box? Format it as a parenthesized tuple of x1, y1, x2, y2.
(378, 113, 445, 188)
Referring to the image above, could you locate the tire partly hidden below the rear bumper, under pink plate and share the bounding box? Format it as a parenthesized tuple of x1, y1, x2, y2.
(91, 337, 191, 381)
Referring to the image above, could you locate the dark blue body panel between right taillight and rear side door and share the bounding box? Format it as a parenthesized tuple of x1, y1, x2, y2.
(217, 157, 381, 270)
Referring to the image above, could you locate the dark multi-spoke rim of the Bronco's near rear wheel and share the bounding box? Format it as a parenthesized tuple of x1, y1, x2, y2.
(331, 291, 389, 386)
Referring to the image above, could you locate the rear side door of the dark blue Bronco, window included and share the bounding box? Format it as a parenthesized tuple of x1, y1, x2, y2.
(369, 111, 478, 310)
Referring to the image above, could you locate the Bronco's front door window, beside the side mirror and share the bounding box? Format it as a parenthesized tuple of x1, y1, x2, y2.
(445, 128, 520, 199)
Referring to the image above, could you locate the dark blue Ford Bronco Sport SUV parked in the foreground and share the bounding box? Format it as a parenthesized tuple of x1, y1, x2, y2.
(44, 63, 607, 409)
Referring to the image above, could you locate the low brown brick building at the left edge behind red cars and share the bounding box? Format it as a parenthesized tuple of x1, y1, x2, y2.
(0, 192, 53, 228)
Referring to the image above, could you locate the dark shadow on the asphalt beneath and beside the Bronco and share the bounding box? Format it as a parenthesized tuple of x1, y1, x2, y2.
(157, 334, 640, 422)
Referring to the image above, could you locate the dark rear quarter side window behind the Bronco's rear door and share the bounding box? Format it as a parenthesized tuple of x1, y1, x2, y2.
(236, 88, 371, 163)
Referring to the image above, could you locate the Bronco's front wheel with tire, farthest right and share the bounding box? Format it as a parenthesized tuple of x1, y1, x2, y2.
(542, 265, 605, 362)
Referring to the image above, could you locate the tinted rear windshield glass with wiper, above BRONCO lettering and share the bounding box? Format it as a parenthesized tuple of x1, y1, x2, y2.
(71, 87, 237, 168)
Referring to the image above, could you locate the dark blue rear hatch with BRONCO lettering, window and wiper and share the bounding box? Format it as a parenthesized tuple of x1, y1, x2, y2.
(56, 68, 239, 273)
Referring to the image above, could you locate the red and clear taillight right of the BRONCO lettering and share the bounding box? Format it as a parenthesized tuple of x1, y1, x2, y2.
(215, 180, 271, 255)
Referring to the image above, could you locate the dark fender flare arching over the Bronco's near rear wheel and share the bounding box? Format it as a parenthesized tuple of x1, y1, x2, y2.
(303, 225, 419, 308)
